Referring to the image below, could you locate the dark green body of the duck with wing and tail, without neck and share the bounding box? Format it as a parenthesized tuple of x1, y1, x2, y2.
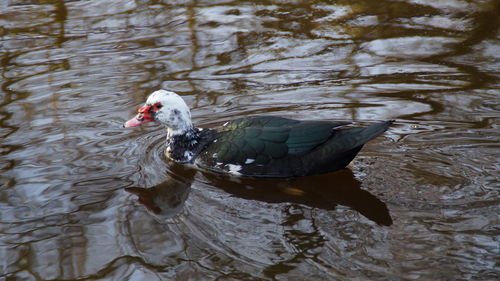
(196, 116, 391, 177)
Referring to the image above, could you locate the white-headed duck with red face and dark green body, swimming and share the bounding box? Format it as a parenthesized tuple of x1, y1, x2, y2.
(123, 89, 394, 178)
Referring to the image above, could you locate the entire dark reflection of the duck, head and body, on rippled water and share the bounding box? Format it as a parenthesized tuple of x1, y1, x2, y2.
(125, 164, 392, 226)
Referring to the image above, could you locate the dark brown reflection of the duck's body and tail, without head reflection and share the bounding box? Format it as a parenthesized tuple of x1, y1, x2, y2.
(201, 169, 392, 226)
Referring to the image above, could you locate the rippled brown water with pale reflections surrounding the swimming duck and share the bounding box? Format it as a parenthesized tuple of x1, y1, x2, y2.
(0, 0, 500, 280)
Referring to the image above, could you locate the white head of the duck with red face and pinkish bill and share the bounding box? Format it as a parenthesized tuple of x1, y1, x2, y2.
(124, 90, 193, 136)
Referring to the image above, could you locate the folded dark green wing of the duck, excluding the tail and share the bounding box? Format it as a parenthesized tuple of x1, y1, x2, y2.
(193, 116, 349, 176)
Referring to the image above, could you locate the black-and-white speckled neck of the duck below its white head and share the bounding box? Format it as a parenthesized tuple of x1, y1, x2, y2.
(166, 126, 201, 163)
